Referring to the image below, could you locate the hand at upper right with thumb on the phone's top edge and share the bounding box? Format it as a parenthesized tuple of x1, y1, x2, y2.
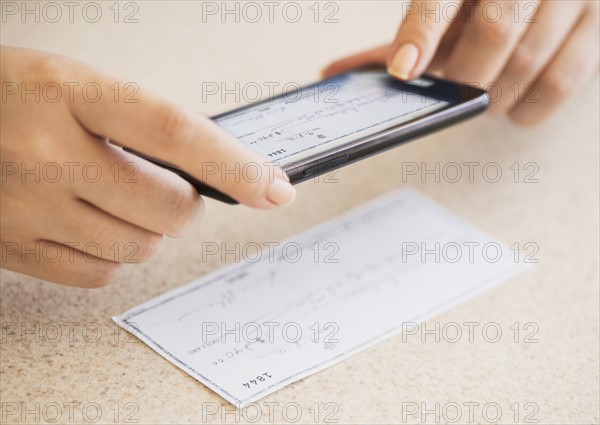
(324, 0, 600, 125)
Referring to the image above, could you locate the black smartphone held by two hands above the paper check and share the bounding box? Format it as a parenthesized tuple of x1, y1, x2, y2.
(134, 69, 489, 204)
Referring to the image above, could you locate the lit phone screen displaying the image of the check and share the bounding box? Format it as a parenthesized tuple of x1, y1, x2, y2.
(213, 71, 450, 165)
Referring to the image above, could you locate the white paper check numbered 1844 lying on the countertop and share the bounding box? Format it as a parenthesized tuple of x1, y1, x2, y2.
(114, 189, 525, 407)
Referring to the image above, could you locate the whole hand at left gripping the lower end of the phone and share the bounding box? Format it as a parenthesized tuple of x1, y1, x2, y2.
(0, 47, 294, 287)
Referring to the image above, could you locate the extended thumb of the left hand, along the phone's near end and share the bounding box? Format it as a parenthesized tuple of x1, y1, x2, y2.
(70, 61, 295, 209)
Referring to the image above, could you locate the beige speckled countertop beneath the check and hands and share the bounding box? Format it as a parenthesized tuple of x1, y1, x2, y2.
(0, 1, 600, 424)
